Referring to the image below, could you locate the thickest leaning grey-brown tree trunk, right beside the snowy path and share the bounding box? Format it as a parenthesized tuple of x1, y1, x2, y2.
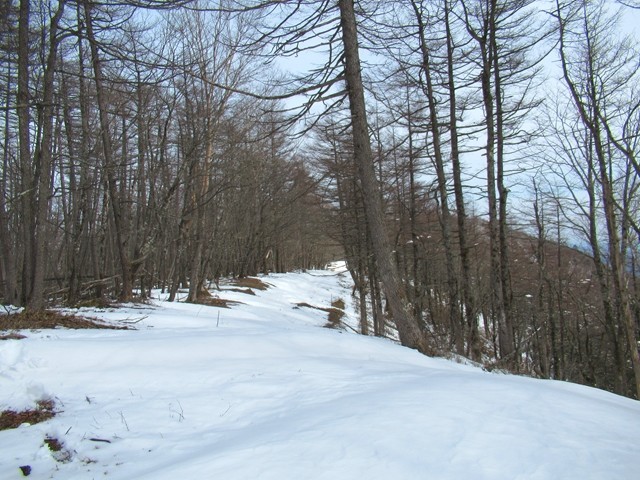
(338, 0, 428, 353)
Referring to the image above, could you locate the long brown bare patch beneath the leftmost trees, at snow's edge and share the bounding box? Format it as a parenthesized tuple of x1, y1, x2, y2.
(0, 310, 128, 332)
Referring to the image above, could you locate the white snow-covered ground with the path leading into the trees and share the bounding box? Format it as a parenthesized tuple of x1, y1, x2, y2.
(0, 271, 640, 480)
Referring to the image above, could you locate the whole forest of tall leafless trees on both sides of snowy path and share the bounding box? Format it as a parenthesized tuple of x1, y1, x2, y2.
(0, 0, 640, 398)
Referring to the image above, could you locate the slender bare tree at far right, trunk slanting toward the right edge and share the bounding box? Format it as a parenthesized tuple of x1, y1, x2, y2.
(555, 1, 640, 397)
